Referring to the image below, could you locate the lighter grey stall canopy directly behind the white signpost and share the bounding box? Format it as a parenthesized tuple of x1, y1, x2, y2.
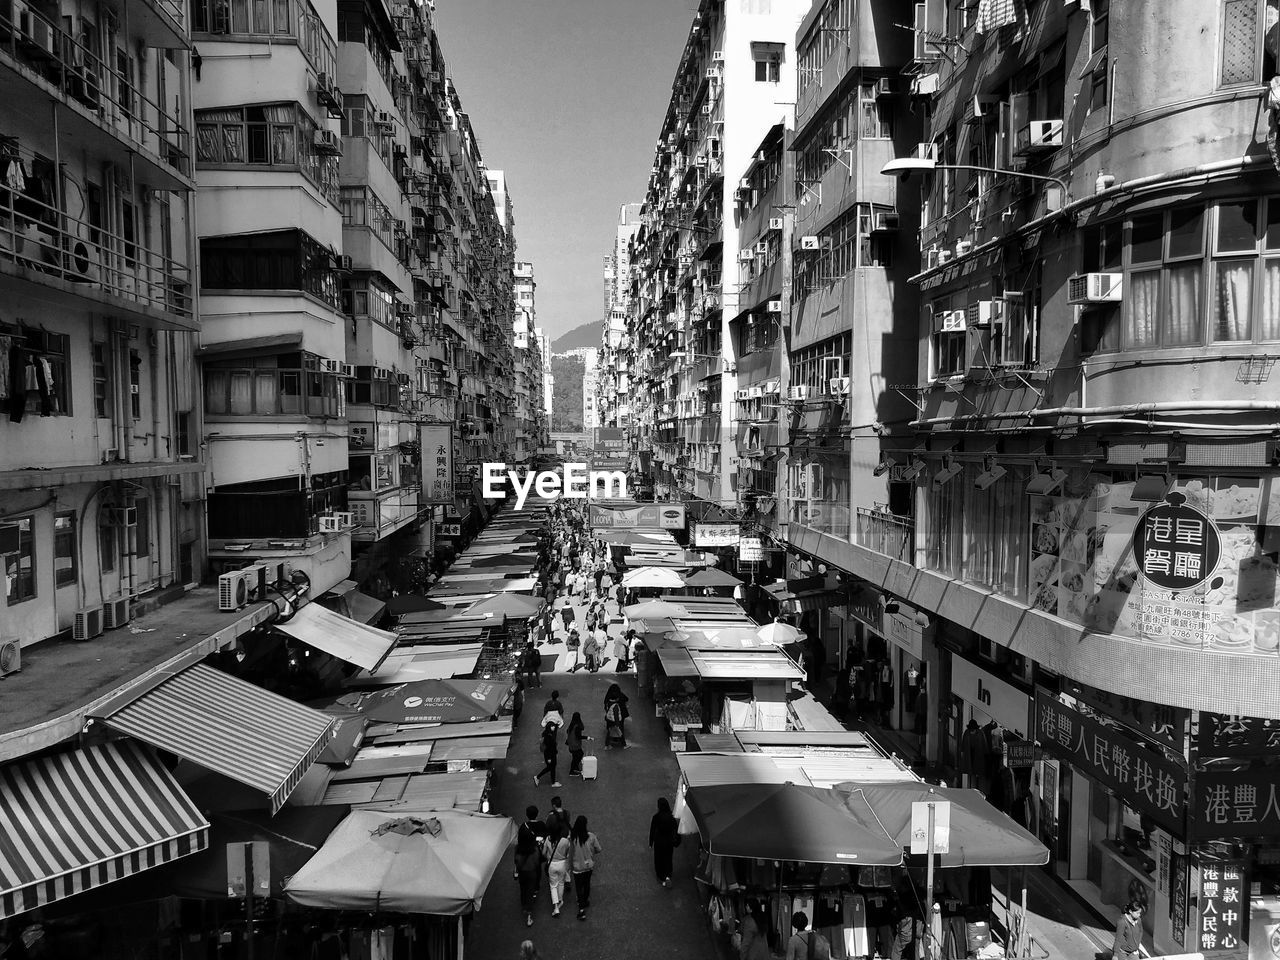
(835, 782, 1048, 867)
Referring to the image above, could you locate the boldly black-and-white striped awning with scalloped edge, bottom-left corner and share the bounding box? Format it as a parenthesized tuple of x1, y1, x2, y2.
(0, 741, 209, 919)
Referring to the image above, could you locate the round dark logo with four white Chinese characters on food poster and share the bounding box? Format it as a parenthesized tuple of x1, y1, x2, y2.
(1133, 493, 1222, 590)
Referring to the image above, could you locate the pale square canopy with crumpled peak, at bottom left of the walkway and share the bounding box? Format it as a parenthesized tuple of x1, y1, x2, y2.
(285, 810, 516, 916)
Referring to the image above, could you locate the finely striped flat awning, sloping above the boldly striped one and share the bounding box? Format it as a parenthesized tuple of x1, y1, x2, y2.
(97, 663, 334, 812)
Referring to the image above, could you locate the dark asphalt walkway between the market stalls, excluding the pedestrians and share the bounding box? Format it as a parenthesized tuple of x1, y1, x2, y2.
(467, 586, 716, 960)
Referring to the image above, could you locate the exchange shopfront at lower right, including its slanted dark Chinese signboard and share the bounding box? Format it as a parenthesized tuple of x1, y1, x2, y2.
(1034, 690, 1187, 954)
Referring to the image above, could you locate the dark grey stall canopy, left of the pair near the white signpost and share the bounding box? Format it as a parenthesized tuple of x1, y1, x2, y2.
(685, 783, 910, 867)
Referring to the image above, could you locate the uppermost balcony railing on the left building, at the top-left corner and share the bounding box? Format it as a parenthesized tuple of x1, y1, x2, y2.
(0, 3, 191, 177)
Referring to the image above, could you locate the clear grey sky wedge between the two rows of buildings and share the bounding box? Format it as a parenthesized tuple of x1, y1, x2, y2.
(435, 0, 698, 340)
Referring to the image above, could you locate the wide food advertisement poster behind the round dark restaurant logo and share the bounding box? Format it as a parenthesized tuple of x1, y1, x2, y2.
(1028, 471, 1280, 657)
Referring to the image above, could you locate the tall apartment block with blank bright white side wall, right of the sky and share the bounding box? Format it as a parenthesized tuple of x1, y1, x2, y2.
(628, 0, 808, 512)
